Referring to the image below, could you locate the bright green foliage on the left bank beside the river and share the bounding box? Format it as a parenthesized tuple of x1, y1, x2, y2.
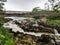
(0, 17, 14, 45)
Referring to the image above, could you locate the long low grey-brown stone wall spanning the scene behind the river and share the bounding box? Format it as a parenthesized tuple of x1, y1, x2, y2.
(0, 12, 60, 17)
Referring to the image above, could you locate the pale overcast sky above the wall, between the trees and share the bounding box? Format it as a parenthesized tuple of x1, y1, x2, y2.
(4, 0, 47, 11)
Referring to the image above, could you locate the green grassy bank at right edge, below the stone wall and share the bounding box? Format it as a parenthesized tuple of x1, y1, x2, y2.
(47, 16, 60, 26)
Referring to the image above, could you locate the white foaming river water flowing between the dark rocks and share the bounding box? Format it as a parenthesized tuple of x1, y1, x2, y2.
(3, 17, 58, 36)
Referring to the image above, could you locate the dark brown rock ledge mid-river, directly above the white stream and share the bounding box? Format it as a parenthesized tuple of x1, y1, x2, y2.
(15, 20, 54, 33)
